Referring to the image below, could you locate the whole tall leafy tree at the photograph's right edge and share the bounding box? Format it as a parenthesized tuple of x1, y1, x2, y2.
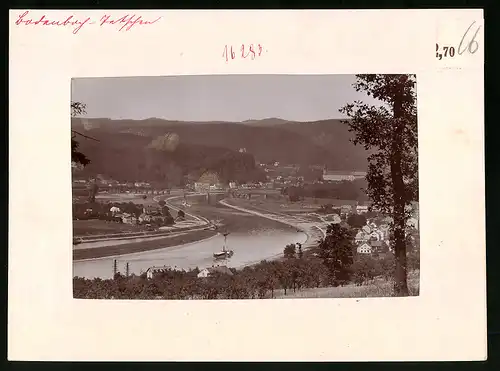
(340, 75, 418, 296)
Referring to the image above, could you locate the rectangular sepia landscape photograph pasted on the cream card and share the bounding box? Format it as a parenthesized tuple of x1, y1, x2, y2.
(72, 74, 420, 300)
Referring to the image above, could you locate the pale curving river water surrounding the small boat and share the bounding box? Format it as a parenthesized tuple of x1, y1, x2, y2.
(73, 198, 308, 279)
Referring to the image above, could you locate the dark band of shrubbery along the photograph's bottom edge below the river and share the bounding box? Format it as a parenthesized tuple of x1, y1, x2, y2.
(73, 259, 331, 299)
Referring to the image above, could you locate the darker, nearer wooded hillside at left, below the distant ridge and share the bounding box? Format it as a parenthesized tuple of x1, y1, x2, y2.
(74, 129, 266, 188)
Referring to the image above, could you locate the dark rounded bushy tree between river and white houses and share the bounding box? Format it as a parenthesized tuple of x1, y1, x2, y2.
(318, 224, 354, 283)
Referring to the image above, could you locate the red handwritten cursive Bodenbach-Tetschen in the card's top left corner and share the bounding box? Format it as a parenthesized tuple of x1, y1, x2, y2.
(16, 11, 161, 34)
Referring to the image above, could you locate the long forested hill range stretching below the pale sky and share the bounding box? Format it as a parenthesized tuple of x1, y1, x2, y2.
(72, 118, 367, 185)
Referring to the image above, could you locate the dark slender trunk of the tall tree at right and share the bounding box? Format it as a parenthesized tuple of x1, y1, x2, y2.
(390, 95, 409, 296)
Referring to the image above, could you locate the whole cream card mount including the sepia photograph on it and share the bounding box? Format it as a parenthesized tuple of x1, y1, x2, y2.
(8, 10, 487, 361)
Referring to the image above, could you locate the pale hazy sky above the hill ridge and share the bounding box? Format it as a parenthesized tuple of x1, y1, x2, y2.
(71, 75, 376, 122)
